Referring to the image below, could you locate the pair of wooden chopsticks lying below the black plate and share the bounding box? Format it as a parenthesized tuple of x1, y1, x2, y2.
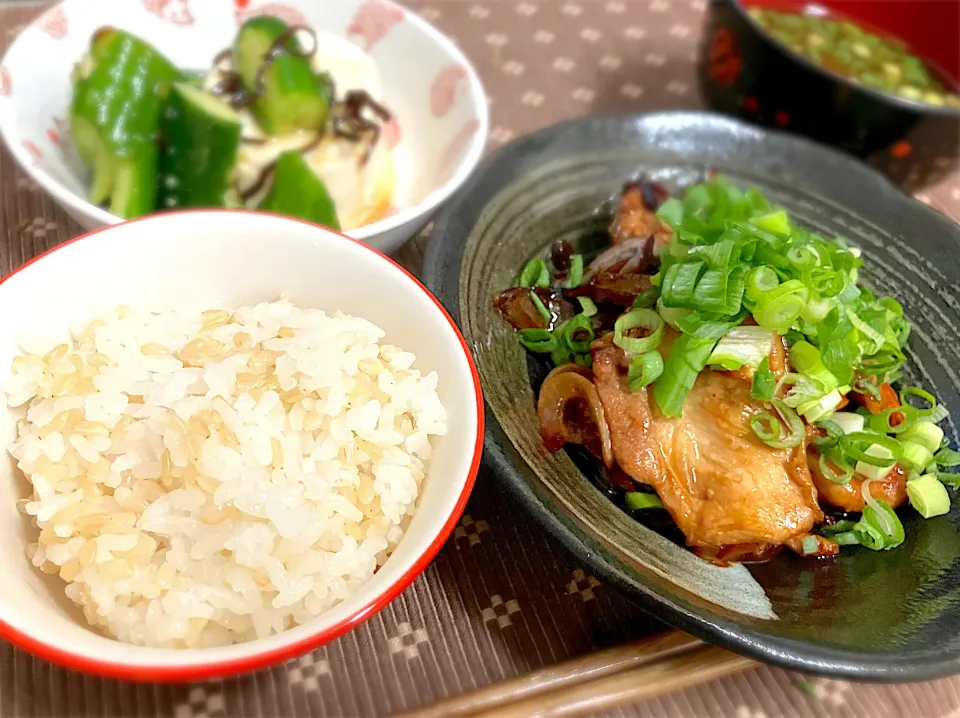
(396, 631, 751, 718)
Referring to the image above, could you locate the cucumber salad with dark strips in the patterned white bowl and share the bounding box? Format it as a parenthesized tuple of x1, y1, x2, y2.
(70, 15, 395, 229)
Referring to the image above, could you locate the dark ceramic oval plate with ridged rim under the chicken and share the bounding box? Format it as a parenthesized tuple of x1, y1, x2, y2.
(425, 113, 960, 680)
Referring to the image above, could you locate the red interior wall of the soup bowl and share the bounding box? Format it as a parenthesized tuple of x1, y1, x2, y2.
(742, 0, 960, 84)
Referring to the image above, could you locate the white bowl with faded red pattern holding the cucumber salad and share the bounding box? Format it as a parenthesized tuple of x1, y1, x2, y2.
(0, 0, 489, 252)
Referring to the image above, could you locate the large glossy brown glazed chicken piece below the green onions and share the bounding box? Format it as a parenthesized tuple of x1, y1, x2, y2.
(593, 340, 823, 548)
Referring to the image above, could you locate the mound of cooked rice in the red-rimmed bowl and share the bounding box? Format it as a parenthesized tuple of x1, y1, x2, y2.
(3, 300, 446, 648)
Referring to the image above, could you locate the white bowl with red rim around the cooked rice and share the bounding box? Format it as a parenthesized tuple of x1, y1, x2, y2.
(0, 208, 483, 681)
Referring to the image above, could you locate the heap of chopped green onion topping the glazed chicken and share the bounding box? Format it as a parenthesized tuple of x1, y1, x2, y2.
(615, 177, 948, 516)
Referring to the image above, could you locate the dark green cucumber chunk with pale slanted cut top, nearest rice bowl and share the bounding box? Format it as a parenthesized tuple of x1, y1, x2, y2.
(159, 82, 241, 210)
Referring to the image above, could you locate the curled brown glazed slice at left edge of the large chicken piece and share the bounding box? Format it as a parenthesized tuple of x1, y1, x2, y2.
(537, 364, 613, 468)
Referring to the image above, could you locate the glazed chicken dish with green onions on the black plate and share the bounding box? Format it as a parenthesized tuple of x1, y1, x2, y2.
(494, 178, 960, 563)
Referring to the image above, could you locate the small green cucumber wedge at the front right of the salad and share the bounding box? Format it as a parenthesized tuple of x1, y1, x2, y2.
(258, 152, 340, 230)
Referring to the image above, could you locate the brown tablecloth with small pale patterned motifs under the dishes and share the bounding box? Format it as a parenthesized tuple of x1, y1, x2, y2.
(0, 0, 960, 718)
